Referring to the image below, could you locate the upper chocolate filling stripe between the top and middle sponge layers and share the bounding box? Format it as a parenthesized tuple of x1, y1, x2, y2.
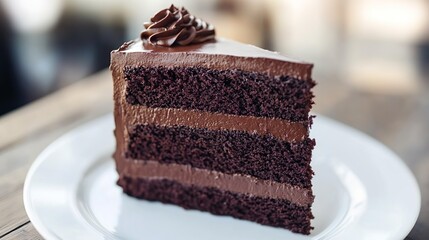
(125, 105, 308, 142)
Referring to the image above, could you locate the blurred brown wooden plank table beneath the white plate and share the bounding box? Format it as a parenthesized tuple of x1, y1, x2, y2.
(0, 70, 429, 240)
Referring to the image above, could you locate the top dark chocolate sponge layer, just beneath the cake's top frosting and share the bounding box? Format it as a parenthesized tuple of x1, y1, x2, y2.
(124, 67, 315, 121)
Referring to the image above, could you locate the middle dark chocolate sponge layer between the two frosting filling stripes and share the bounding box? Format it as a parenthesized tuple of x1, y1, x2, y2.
(126, 125, 315, 188)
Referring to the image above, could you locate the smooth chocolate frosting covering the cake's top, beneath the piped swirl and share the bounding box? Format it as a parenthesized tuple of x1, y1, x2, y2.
(112, 38, 313, 81)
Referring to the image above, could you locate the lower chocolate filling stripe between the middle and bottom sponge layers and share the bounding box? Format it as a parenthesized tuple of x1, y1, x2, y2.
(118, 159, 314, 206)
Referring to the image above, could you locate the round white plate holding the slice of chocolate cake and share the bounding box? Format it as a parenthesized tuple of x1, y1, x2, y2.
(24, 115, 420, 240)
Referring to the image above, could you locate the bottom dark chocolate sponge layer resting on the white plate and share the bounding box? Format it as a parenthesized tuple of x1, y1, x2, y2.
(118, 176, 313, 234)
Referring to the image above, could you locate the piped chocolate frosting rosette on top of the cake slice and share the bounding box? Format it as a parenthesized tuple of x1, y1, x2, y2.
(140, 5, 215, 47)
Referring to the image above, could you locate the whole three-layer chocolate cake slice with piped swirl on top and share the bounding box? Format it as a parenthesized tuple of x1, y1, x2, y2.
(110, 6, 315, 234)
